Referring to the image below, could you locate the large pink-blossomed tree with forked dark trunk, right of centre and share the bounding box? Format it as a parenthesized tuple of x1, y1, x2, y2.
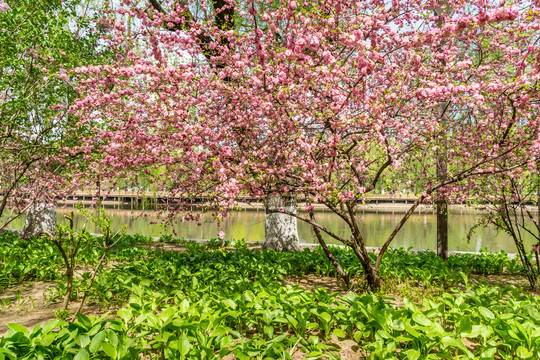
(72, 0, 540, 289)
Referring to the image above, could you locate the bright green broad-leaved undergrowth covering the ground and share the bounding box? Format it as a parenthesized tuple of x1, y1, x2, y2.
(0, 232, 540, 360)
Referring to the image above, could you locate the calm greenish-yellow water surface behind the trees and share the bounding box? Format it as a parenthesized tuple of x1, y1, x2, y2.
(7, 208, 533, 253)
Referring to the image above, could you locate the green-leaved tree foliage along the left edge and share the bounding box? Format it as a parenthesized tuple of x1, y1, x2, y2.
(0, 0, 107, 230)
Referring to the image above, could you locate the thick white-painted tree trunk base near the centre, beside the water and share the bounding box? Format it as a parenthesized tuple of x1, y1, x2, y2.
(262, 194, 300, 251)
